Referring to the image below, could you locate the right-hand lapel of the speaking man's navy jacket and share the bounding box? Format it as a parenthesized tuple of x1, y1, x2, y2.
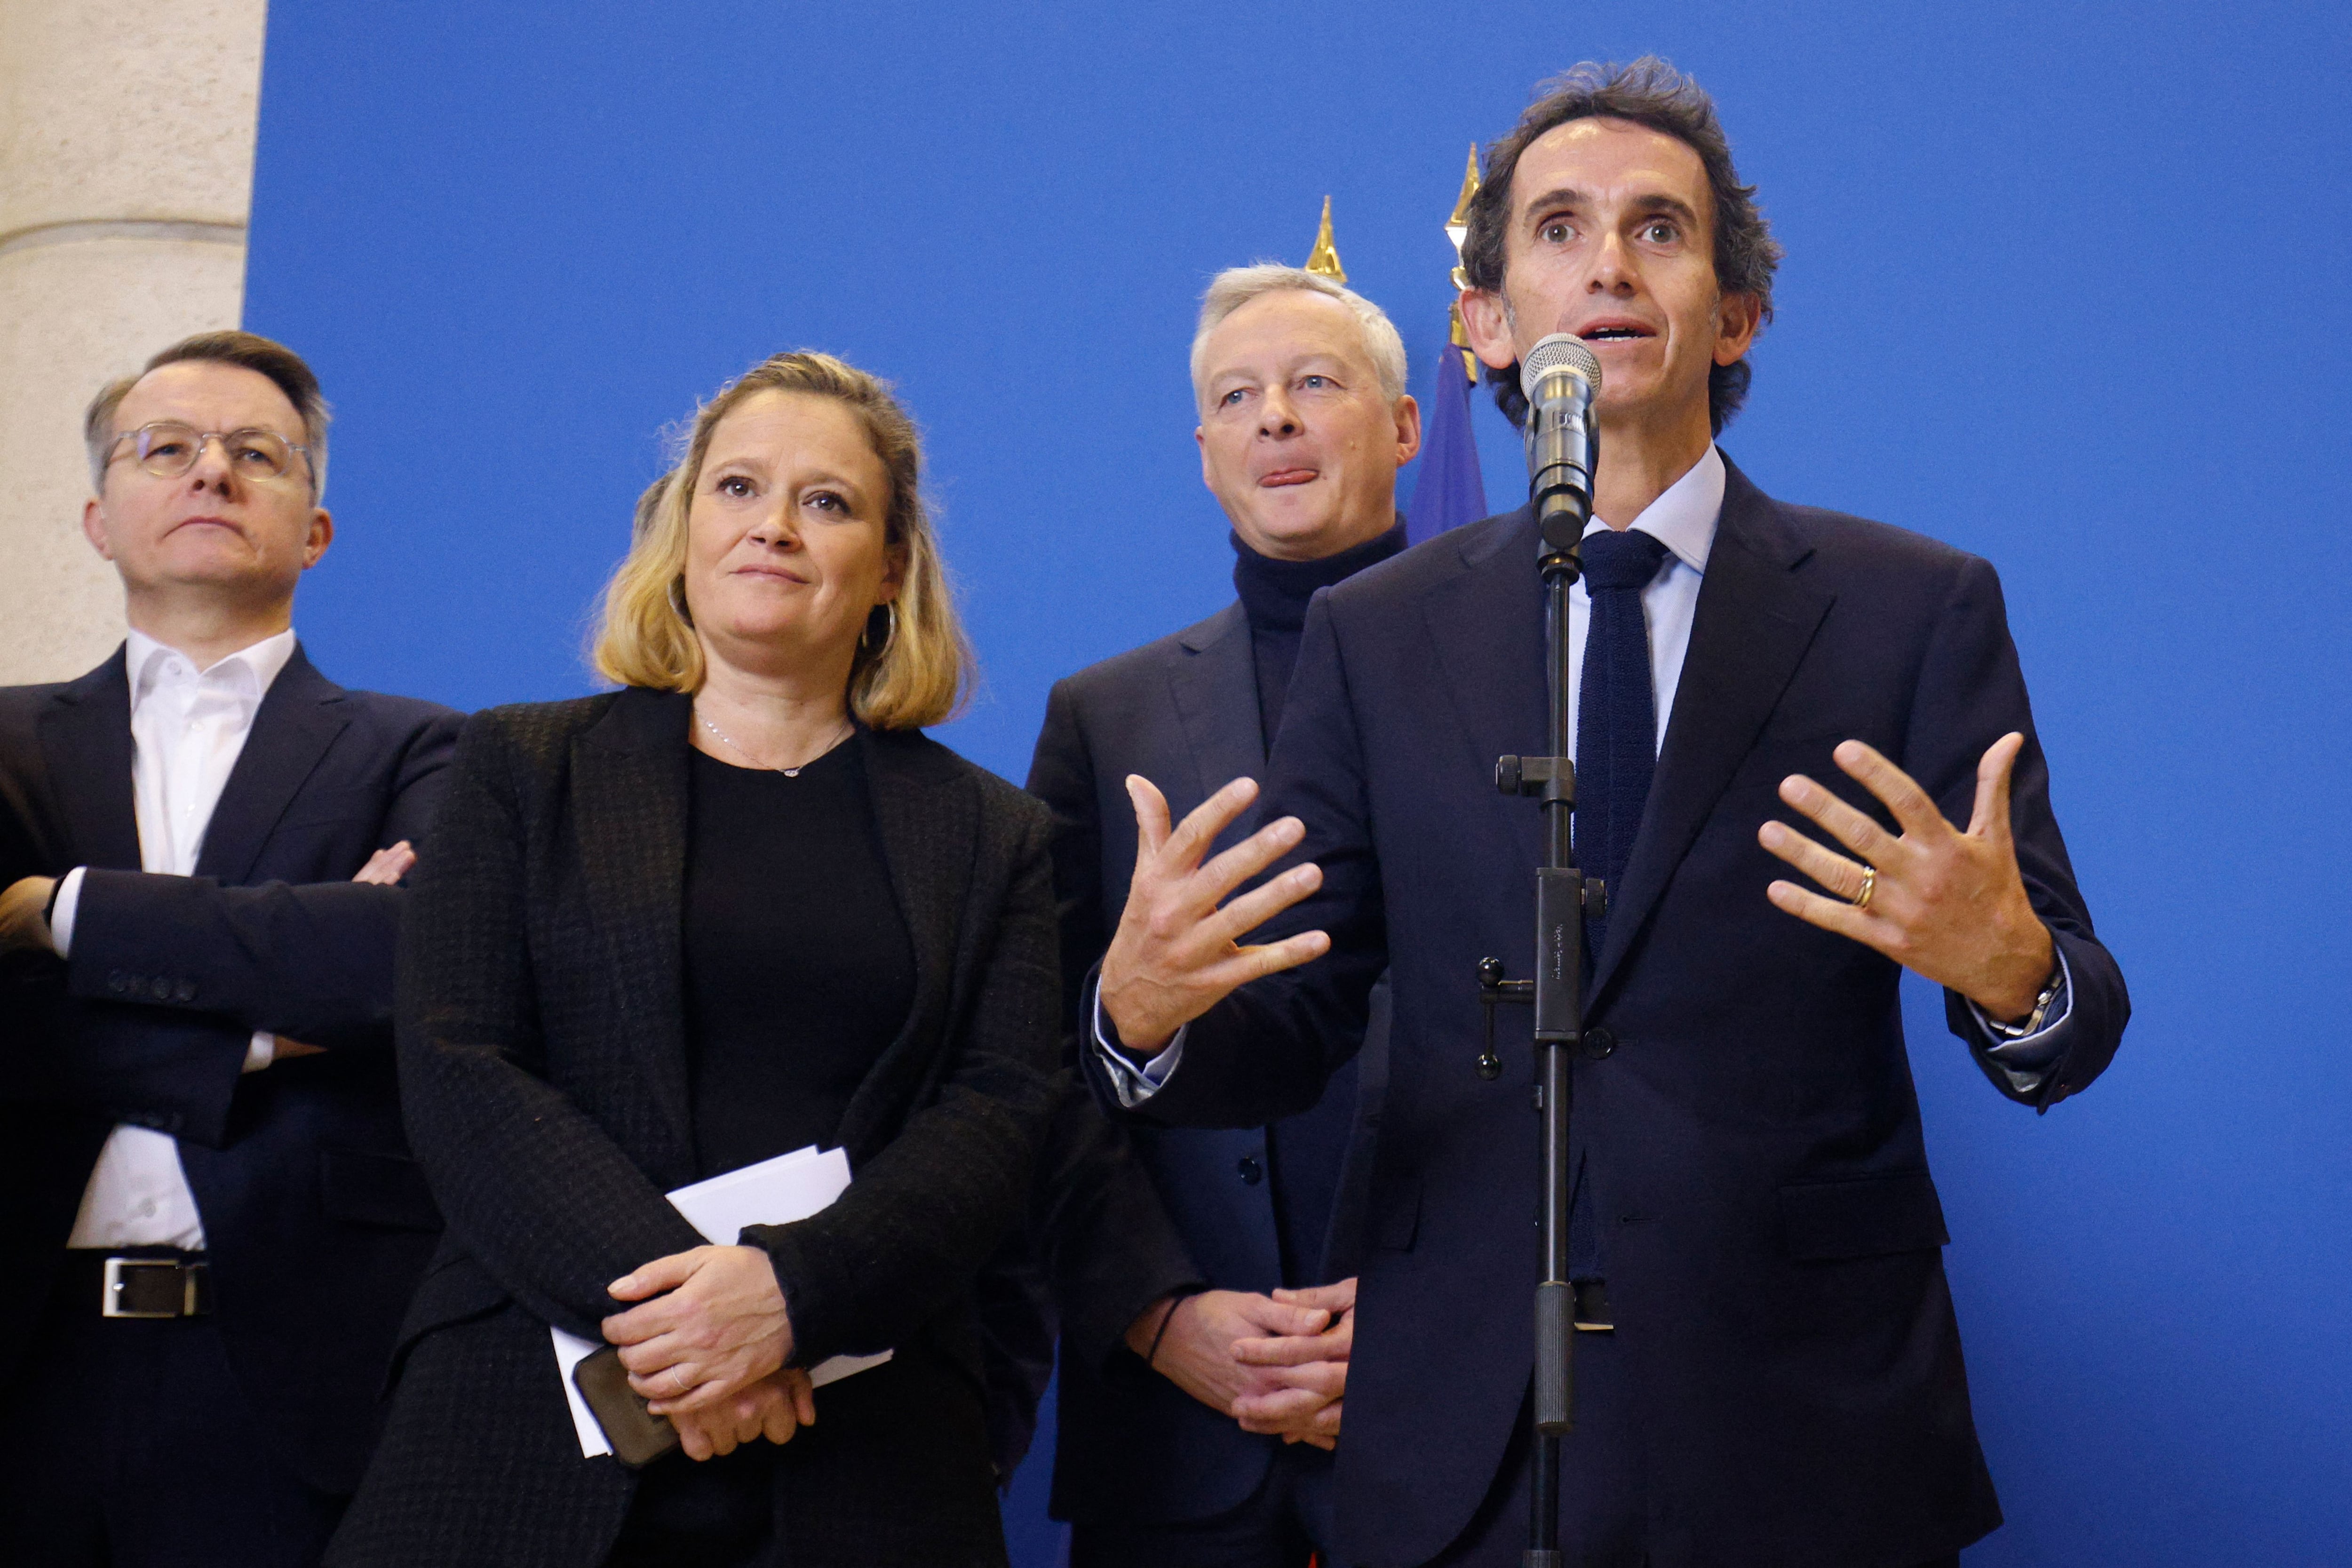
(1592, 461, 1835, 999)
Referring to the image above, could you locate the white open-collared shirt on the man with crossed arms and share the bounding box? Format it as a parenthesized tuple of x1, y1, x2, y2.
(49, 630, 294, 1250)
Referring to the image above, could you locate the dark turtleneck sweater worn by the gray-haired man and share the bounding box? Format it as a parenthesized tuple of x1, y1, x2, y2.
(1232, 517, 1404, 1286)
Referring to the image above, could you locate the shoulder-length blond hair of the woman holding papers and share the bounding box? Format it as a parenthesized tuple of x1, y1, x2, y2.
(590, 350, 971, 729)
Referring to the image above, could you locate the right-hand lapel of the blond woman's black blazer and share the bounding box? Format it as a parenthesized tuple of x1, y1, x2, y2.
(840, 729, 981, 1159)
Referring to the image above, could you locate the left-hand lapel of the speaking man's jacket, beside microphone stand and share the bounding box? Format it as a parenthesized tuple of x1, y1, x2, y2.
(1423, 508, 1545, 870)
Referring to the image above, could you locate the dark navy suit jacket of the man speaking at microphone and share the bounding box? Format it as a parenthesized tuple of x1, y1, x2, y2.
(1091, 456, 2129, 1568)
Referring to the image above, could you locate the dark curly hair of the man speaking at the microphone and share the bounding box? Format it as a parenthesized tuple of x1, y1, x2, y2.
(1463, 54, 1783, 435)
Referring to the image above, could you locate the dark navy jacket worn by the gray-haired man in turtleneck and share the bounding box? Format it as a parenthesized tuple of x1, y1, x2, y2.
(1028, 604, 1385, 1521)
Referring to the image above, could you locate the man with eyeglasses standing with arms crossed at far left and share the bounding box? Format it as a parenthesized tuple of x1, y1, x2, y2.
(0, 332, 459, 1568)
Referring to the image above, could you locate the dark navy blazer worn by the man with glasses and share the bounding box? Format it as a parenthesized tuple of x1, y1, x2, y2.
(0, 649, 459, 1493)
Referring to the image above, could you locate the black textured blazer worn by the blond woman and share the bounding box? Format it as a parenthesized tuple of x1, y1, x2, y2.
(329, 689, 1056, 1568)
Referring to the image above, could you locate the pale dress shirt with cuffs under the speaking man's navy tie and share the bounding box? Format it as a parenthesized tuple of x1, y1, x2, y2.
(1094, 444, 2074, 1105)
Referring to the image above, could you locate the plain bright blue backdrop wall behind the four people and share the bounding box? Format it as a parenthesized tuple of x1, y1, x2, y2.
(247, 0, 2352, 1568)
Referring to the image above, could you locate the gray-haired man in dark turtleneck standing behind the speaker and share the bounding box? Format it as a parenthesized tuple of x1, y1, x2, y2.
(1028, 266, 1421, 1568)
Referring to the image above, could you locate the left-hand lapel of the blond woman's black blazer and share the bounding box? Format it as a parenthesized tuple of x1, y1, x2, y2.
(572, 686, 694, 1169)
